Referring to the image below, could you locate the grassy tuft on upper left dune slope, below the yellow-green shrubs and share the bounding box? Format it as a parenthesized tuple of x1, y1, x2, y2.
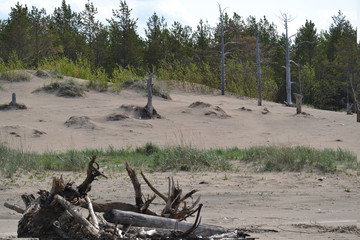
(36, 79, 86, 97)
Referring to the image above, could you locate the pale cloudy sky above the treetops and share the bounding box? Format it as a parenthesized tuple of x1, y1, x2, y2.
(0, 0, 360, 42)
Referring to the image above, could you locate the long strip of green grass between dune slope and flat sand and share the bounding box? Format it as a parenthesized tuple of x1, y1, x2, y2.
(0, 143, 360, 177)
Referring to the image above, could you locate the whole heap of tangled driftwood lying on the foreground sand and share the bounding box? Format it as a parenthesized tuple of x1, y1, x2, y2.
(4, 156, 250, 239)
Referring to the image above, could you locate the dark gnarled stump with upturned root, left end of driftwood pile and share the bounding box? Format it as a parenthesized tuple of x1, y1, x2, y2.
(18, 156, 106, 238)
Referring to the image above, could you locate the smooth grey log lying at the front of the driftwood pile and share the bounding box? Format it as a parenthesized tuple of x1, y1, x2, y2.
(104, 210, 225, 237)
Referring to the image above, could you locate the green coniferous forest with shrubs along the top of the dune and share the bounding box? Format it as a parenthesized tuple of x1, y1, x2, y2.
(0, 0, 360, 110)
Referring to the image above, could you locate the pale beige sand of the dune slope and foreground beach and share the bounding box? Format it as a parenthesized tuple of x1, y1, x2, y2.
(0, 72, 360, 239)
